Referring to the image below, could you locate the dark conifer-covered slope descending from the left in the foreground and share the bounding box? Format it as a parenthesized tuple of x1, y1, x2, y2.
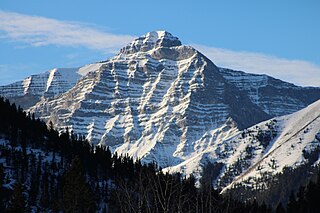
(0, 98, 320, 213)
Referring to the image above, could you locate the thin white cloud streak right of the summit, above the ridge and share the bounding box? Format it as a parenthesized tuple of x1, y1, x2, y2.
(193, 45, 320, 86)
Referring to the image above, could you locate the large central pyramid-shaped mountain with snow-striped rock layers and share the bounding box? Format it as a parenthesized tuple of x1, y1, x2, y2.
(30, 32, 270, 167)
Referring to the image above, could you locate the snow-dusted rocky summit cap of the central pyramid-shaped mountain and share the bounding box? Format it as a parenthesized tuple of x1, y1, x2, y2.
(120, 31, 181, 54)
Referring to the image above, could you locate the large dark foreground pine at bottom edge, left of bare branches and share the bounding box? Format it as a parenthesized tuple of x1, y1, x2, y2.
(63, 157, 95, 212)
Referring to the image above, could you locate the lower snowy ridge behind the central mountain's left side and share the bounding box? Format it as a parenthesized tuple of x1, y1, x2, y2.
(0, 63, 100, 109)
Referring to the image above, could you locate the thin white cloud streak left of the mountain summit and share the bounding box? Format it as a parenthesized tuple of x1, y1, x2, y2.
(0, 10, 134, 52)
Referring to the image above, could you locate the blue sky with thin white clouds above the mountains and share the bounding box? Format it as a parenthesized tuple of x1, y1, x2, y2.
(0, 0, 320, 86)
